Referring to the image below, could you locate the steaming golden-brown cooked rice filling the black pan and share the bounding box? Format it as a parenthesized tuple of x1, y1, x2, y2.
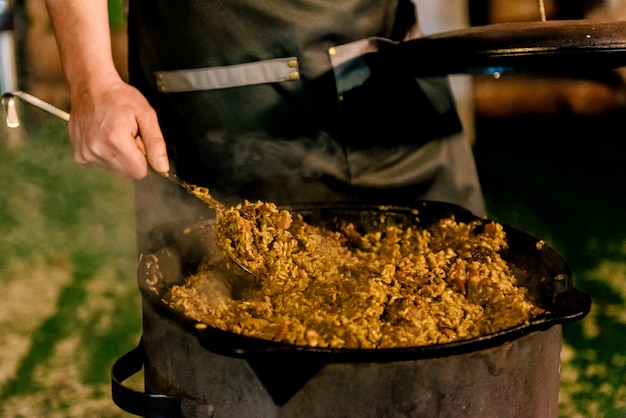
(167, 202, 543, 348)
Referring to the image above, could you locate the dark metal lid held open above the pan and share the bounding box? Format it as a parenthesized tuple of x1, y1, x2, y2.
(380, 20, 626, 76)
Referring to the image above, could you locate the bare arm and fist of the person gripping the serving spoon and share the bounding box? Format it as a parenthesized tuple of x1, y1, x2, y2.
(46, 0, 169, 179)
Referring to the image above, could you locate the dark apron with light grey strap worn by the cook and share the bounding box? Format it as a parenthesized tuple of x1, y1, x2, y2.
(129, 0, 484, 248)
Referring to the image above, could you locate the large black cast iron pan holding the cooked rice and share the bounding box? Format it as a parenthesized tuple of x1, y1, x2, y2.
(138, 201, 591, 362)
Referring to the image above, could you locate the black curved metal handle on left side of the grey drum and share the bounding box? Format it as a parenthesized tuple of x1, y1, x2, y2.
(111, 340, 214, 418)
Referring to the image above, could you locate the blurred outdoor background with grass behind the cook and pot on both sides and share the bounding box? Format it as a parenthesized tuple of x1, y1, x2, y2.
(0, 0, 626, 417)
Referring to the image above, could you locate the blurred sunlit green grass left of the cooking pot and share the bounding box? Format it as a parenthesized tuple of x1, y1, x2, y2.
(0, 109, 141, 417)
